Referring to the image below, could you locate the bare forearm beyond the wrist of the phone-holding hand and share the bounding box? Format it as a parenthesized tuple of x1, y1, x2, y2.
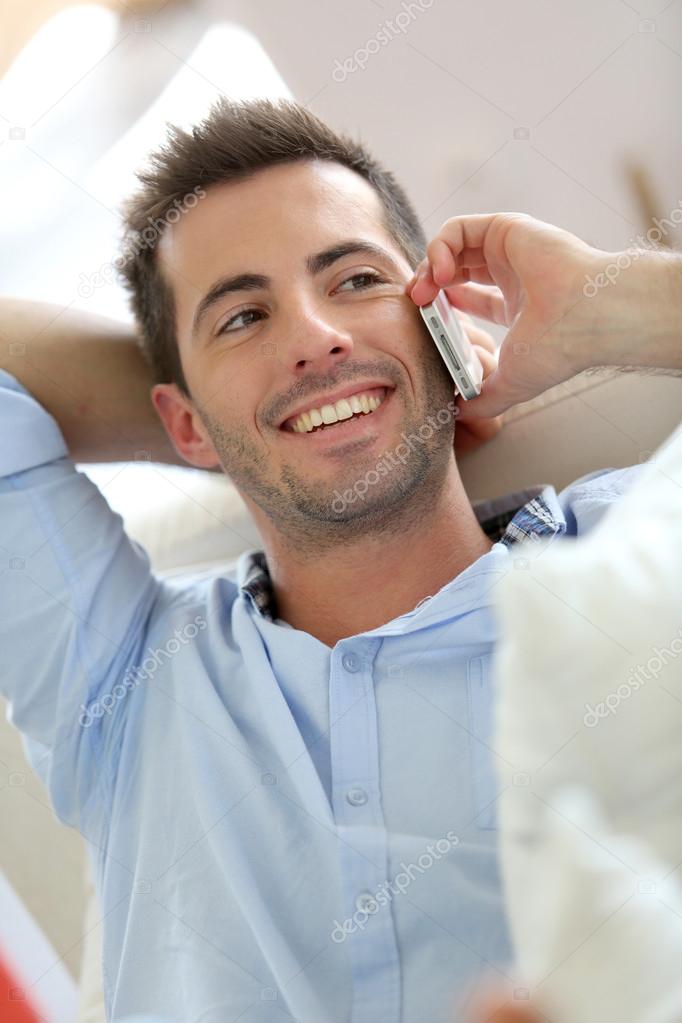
(576, 251, 682, 373)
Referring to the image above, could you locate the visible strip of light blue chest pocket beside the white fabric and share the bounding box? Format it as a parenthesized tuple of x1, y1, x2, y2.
(466, 657, 499, 831)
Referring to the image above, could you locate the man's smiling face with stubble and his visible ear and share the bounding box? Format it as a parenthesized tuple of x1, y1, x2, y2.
(154, 162, 453, 542)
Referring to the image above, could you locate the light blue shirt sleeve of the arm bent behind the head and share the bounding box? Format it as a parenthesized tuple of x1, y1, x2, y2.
(0, 370, 161, 834)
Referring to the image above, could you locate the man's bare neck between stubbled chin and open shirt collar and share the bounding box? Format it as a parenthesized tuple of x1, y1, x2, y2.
(253, 459, 493, 647)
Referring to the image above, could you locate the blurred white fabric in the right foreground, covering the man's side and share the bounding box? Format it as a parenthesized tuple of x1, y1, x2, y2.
(493, 417, 682, 1023)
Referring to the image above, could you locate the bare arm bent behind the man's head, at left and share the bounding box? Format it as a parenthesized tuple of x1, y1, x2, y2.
(0, 297, 186, 464)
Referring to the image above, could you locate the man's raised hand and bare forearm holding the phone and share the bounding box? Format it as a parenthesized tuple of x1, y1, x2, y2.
(406, 213, 682, 420)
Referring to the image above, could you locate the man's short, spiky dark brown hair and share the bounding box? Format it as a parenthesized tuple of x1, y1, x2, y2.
(117, 97, 426, 395)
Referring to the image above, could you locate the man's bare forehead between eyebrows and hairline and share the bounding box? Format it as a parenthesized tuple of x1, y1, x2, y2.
(157, 161, 399, 306)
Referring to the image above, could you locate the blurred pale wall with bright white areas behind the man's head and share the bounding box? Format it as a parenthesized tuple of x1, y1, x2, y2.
(0, 0, 682, 318)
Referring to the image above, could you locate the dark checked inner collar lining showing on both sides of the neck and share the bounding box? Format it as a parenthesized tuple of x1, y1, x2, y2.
(237, 484, 566, 622)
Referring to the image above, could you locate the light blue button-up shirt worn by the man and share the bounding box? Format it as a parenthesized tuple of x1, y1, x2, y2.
(0, 372, 639, 1023)
